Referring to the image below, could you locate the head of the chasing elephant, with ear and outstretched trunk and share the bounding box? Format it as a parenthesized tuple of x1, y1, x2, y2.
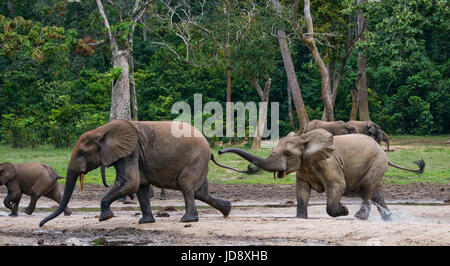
(219, 129, 335, 178)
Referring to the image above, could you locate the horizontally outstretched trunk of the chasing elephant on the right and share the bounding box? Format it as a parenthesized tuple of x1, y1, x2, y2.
(219, 148, 286, 178)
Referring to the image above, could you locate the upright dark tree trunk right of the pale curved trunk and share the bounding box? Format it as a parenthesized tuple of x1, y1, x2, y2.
(356, 0, 370, 121)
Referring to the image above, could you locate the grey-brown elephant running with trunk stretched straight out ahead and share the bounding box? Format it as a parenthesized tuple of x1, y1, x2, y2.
(219, 129, 425, 220)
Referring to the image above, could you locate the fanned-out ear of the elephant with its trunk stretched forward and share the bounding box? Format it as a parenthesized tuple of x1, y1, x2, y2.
(301, 128, 336, 162)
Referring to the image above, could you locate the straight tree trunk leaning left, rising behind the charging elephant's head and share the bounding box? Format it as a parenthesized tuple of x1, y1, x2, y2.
(272, 0, 309, 130)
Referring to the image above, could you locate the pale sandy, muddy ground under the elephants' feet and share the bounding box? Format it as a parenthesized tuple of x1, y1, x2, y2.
(0, 183, 450, 246)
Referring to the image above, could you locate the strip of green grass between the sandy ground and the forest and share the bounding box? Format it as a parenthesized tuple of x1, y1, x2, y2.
(0, 136, 450, 184)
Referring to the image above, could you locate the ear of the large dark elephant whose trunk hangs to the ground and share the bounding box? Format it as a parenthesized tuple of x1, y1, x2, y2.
(97, 120, 138, 166)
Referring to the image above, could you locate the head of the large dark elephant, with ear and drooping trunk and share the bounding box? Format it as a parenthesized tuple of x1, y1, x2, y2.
(40, 120, 138, 226)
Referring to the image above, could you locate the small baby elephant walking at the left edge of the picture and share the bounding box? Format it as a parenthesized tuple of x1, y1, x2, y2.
(0, 162, 72, 216)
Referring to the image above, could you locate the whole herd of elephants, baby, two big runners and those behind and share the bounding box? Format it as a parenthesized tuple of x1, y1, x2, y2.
(0, 120, 425, 226)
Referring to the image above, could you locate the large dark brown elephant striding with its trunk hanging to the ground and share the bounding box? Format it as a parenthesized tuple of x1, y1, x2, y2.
(39, 120, 241, 226)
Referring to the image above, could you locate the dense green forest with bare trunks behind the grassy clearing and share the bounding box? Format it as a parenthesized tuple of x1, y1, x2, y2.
(0, 0, 450, 147)
